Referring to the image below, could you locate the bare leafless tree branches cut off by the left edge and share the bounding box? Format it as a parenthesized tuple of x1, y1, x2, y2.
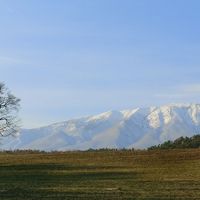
(0, 83, 20, 136)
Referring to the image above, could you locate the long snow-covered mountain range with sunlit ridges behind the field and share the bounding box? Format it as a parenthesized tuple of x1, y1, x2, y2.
(1, 104, 200, 151)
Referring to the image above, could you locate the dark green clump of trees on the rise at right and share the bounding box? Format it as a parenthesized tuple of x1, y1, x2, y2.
(149, 135, 200, 150)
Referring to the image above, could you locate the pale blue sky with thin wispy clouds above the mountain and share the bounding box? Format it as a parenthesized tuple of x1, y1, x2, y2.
(0, 0, 200, 128)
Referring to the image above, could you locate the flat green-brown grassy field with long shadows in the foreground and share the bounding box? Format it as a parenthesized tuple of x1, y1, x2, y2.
(0, 149, 200, 200)
